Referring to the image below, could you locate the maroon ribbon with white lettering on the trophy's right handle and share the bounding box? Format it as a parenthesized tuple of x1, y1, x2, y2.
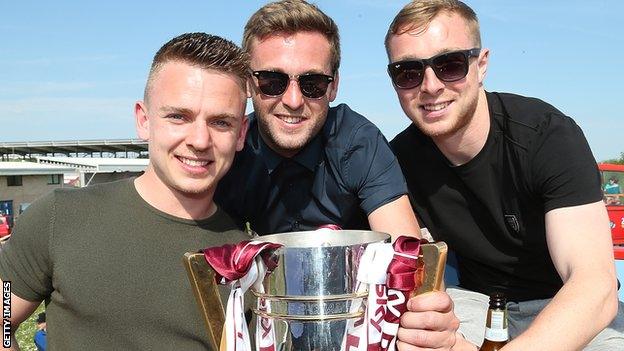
(380, 236, 424, 351)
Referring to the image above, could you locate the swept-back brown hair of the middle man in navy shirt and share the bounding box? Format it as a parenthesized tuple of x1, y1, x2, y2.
(243, 0, 340, 74)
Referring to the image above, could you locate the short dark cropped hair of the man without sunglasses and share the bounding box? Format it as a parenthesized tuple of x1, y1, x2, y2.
(144, 33, 249, 100)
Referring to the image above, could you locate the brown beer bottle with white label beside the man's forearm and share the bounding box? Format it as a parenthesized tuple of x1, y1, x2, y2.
(479, 292, 509, 351)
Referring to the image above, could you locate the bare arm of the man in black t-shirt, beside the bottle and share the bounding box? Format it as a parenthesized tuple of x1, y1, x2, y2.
(504, 201, 618, 350)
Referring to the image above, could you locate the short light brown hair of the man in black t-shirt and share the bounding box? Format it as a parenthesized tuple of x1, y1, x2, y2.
(385, 0, 481, 52)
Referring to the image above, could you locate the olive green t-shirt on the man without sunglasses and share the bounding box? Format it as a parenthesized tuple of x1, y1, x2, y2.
(0, 179, 249, 351)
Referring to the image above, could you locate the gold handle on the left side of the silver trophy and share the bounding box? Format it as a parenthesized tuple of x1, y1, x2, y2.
(183, 252, 225, 350)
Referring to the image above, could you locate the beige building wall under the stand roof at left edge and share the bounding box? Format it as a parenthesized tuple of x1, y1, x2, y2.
(0, 174, 63, 218)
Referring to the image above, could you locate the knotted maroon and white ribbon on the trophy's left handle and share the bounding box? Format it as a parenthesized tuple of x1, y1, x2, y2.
(204, 241, 282, 351)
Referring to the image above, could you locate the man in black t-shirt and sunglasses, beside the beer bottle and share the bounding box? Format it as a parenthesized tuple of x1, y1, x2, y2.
(386, 0, 624, 350)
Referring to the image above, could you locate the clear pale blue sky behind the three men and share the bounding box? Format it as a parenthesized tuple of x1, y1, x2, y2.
(0, 0, 624, 160)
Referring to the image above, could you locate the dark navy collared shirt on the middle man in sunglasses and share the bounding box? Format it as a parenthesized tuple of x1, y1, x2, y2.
(215, 104, 407, 234)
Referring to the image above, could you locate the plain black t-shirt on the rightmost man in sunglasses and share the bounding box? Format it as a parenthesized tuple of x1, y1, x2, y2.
(391, 93, 602, 301)
